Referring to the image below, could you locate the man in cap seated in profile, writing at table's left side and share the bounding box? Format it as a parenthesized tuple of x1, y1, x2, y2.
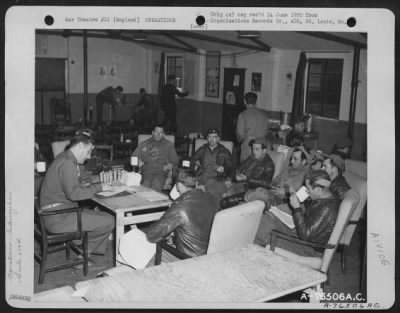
(40, 129, 115, 264)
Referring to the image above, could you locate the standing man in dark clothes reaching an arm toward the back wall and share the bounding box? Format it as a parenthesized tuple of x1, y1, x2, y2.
(160, 75, 189, 132)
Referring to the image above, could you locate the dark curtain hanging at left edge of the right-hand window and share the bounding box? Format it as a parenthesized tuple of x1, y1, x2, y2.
(292, 52, 307, 123)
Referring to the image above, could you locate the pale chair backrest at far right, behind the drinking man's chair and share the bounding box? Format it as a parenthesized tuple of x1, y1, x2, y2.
(340, 171, 367, 245)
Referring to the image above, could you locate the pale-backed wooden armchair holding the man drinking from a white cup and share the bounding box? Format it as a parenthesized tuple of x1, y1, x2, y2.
(267, 189, 360, 288)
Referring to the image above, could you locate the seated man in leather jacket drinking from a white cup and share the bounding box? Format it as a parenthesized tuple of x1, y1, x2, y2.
(255, 170, 340, 256)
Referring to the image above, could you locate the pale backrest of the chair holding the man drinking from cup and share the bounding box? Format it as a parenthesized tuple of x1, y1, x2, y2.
(320, 189, 360, 273)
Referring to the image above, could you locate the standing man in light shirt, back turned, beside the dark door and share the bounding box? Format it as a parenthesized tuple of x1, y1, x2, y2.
(236, 92, 269, 162)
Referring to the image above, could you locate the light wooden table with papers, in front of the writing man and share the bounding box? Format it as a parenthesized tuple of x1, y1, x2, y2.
(92, 186, 171, 264)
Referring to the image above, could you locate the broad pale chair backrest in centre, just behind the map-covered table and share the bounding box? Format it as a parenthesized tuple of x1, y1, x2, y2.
(207, 200, 265, 254)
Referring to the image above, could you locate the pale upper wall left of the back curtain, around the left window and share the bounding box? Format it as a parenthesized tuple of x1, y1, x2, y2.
(35, 35, 152, 124)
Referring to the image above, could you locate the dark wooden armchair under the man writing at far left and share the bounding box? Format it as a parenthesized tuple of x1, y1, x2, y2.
(34, 198, 88, 284)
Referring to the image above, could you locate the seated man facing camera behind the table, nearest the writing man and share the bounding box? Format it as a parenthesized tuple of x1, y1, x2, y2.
(132, 125, 179, 191)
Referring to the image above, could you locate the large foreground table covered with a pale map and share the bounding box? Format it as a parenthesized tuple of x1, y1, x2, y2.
(75, 245, 326, 306)
